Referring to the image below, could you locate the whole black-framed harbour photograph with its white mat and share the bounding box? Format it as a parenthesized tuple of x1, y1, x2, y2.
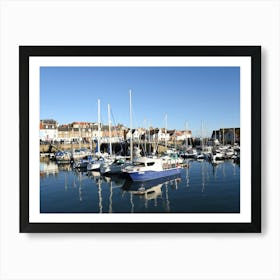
(19, 46, 261, 233)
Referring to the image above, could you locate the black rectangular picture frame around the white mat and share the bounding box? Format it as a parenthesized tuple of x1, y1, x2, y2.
(19, 46, 261, 233)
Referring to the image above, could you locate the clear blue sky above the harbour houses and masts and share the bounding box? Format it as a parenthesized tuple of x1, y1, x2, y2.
(40, 67, 240, 136)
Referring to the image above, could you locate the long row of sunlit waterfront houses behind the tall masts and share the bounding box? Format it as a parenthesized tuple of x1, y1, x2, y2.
(40, 120, 192, 142)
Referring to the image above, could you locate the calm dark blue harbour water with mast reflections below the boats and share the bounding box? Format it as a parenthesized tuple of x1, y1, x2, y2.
(40, 161, 240, 213)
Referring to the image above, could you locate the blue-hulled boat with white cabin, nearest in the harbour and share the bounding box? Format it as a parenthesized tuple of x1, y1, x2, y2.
(122, 157, 182, 181)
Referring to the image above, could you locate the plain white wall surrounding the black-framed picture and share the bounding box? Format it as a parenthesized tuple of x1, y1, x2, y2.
(0, 0, 280, 280)
